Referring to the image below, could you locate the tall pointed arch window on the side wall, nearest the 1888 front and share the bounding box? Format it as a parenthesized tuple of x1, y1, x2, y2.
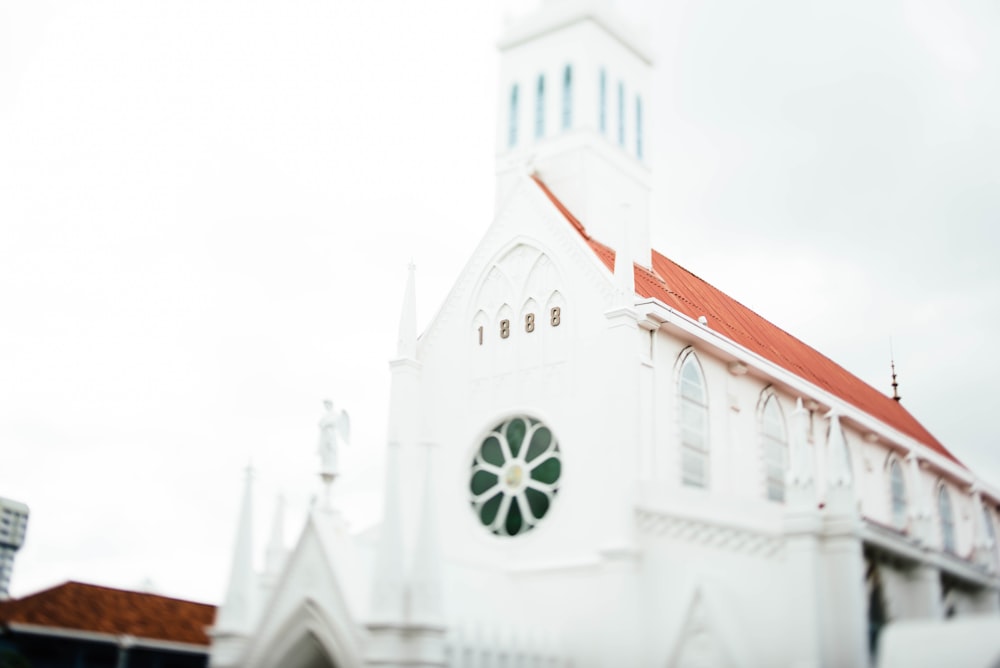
(677, 352, 708, 487)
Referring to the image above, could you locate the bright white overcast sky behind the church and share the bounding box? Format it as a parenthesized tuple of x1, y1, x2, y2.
(0, 0, 1000, 602)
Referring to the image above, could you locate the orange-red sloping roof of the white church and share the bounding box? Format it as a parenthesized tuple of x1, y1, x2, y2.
(532, 175, 961, 464)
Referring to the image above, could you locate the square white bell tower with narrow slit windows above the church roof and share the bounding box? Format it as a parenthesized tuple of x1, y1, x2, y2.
(496, 0, 653, 267)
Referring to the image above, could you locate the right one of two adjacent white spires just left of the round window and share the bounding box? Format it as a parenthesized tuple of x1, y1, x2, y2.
(410, 443, 444, 624)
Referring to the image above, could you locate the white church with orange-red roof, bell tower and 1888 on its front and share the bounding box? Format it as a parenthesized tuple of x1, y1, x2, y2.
(205, 0, 1000, 668)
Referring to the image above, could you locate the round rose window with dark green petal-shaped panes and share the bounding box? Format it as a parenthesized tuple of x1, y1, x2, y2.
(469, 416, 562, 536)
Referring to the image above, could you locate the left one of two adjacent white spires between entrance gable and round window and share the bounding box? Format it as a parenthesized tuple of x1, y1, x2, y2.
(371, 443, 406, 623)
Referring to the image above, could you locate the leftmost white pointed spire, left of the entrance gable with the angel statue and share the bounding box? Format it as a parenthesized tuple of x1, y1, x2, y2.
(215, 465, 256, 634)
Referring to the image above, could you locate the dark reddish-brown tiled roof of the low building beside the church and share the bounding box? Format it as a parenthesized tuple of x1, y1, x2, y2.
(0, 582, 215, 646)
